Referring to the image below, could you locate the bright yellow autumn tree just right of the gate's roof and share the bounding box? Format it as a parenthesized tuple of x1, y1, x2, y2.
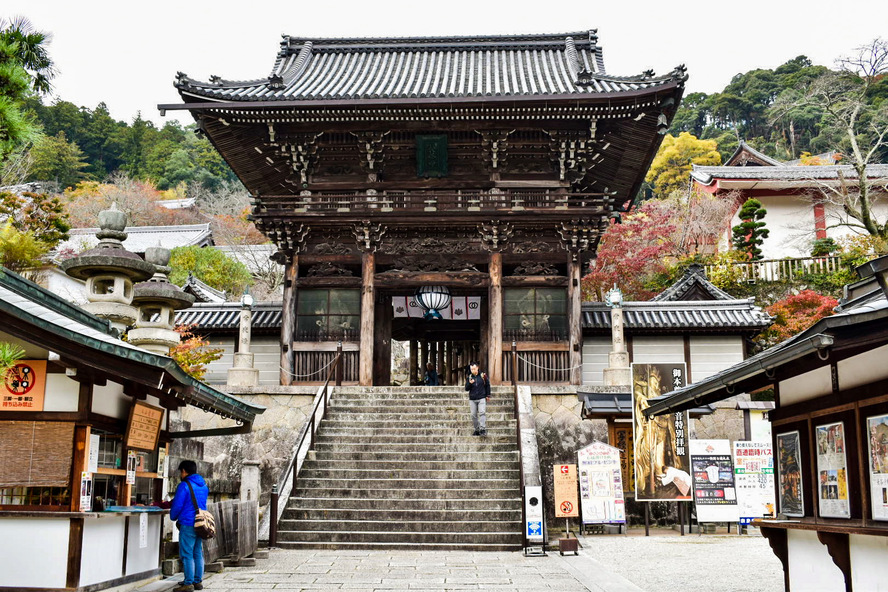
(645, 132, 721, 197)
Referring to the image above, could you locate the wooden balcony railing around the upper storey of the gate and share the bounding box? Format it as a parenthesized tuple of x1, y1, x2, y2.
(253, 189, 611, 215)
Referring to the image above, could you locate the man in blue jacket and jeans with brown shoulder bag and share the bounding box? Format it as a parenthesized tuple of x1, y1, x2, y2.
(170, 460, 210, 592)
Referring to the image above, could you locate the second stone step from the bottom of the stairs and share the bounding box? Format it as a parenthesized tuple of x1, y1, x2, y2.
(278, 517, 521, 540)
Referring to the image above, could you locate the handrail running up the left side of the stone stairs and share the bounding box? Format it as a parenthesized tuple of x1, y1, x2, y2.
(268, 345, 342, 547)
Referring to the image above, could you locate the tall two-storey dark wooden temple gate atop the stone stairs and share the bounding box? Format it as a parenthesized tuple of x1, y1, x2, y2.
(159, 31, 686, 385)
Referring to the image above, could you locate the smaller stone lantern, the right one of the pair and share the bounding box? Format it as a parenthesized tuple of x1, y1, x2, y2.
(127, 246, 194, 356)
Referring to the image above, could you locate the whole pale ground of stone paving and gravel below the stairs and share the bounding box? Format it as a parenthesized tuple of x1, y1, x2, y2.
(140, 531, 783, 592)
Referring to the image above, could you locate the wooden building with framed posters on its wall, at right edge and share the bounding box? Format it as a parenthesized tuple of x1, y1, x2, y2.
(645, 256, 888, 591)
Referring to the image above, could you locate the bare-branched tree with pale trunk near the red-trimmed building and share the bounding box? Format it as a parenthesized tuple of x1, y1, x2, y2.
(774, 39, 888, 238)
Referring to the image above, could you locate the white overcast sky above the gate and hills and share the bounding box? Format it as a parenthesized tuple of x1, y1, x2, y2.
(6, 0, 888, 125)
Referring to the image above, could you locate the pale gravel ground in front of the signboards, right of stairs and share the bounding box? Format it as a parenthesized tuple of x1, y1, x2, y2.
(580, 529, 783, 592)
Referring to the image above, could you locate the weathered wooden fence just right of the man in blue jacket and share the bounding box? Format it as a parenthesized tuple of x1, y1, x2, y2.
(203, 500, 259, 562)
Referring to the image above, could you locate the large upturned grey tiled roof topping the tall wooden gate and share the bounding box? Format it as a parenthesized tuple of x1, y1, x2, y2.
(176, 31, 686, 101)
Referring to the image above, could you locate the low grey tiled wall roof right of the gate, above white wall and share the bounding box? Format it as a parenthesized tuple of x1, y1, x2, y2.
(582, 299, 771, 332)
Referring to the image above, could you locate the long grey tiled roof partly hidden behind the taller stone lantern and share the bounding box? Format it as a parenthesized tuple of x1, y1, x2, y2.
(56, 223, 213, 253)
